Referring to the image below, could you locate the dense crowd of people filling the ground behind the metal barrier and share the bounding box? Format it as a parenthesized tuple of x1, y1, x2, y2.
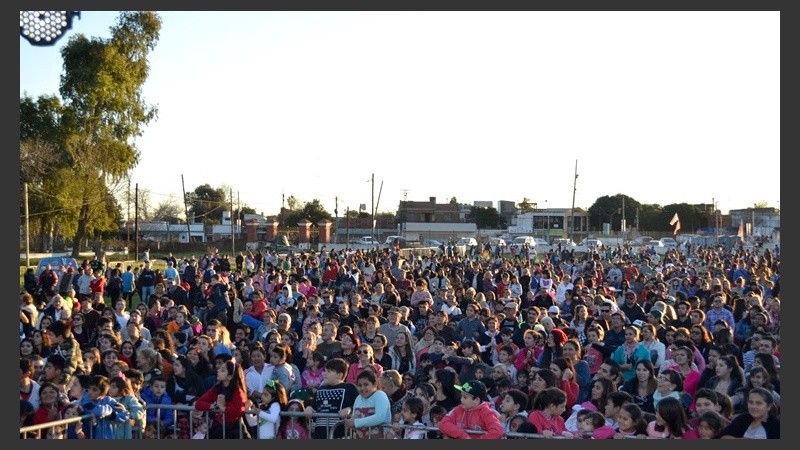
(20, 239, 781, 439)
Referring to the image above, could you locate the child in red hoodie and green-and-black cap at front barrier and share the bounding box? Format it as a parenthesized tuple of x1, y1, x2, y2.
(439, 380, 504, 439)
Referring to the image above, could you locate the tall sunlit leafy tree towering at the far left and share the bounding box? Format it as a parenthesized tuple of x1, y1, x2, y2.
(20, 11, 161, 257)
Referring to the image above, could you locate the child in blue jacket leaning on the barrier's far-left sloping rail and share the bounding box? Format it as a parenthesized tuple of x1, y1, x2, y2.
(79, 375, 130, 439)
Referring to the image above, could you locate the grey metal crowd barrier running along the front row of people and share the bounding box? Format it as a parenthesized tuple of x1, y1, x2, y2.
(19, 405, 616, 439)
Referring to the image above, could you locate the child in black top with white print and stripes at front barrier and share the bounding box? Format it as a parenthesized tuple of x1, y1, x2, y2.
(305, 358, 358, 439)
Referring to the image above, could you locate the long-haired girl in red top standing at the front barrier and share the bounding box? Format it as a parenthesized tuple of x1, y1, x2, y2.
(194, 360, 247, 439)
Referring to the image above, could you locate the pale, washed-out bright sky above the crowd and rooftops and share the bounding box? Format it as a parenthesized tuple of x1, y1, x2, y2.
(20, 11, 780, 220)
